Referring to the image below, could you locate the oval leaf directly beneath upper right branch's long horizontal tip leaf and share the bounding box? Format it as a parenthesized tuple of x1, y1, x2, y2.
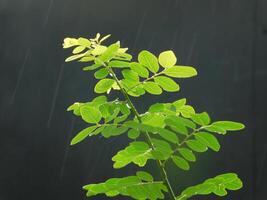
(154, 76, 180, 92)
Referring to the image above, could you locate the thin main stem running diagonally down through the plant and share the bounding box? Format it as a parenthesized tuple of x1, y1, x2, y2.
(104, 65, 176, 200)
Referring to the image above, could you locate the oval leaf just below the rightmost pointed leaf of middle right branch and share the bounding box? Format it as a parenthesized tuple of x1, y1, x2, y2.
(195, 132, 220, 151)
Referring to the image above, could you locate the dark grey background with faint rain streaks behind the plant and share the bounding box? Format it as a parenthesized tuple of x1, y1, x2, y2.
(0, 0, 267, 200)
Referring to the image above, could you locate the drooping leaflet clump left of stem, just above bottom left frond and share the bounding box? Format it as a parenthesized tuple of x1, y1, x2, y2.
(112, 142, 153, 169)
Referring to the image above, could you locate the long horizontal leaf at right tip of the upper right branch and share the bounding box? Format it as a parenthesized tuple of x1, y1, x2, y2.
(163, 66, 197, 78)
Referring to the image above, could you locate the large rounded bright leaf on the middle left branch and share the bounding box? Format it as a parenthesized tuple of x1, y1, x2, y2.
(80, 105, 102, 124)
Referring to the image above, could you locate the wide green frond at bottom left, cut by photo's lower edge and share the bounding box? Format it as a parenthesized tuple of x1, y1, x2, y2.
(83, 172, 167, 200)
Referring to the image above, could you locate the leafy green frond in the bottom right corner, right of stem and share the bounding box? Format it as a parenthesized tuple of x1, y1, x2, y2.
(176, 173, 243, 200)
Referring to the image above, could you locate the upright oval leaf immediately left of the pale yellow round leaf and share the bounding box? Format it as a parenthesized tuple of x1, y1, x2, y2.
(138, 50, 159, 73)
